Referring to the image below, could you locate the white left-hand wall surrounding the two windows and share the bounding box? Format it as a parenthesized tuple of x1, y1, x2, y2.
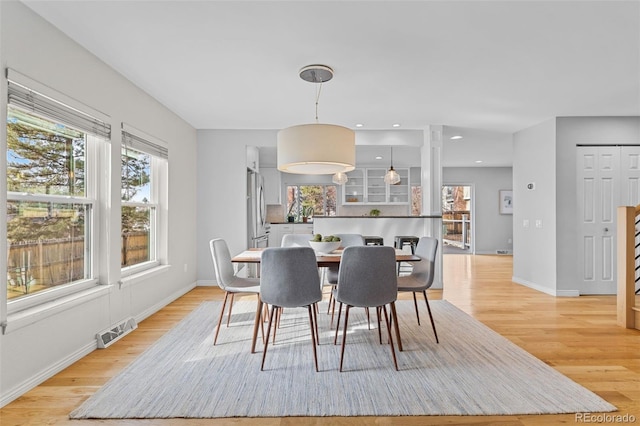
(0, 2, 196, 406)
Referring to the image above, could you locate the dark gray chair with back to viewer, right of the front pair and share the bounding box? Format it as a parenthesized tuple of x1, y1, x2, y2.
(334, 246, 400, 371)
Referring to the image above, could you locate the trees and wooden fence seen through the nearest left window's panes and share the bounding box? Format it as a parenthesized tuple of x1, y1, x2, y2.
(6, 106, 93, 300)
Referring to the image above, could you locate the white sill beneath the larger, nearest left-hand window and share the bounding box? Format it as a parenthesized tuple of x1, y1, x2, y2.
(2, 285, 113, 334)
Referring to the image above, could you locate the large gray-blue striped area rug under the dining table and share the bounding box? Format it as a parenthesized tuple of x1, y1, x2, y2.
(70, 300, 616, 419)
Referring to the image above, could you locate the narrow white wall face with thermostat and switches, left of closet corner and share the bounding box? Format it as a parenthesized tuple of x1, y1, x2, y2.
(513, 119, 556, 294)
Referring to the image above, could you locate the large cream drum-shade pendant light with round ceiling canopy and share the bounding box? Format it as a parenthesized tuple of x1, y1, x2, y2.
(277, 65, 356, 175)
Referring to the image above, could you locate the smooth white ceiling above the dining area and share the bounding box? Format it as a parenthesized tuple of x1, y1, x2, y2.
(23, 0, 640, 165)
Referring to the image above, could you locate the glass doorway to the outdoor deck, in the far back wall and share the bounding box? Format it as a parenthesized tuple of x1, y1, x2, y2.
(442, 185, 474, 254)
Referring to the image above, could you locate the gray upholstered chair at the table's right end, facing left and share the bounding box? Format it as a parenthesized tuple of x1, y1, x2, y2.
(398, 237, 440, 343)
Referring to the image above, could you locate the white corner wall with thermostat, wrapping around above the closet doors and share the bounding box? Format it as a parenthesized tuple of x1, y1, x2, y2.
(513, 117, 640, 296)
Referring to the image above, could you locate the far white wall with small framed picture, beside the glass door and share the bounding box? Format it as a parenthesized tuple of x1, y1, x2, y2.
(442, 167, 513, 254)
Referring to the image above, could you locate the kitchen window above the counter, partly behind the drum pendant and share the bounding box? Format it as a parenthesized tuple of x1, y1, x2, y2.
(287, 185, 337, 221)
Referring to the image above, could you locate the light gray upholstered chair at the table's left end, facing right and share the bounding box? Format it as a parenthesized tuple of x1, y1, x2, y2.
(209, 238, 262, 353)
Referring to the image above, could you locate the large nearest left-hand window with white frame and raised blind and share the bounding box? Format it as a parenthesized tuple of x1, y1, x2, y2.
(6, 81, 110, 310)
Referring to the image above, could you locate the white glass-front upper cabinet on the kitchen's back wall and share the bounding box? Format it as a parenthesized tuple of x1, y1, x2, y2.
(342, 169, 410, 204)
